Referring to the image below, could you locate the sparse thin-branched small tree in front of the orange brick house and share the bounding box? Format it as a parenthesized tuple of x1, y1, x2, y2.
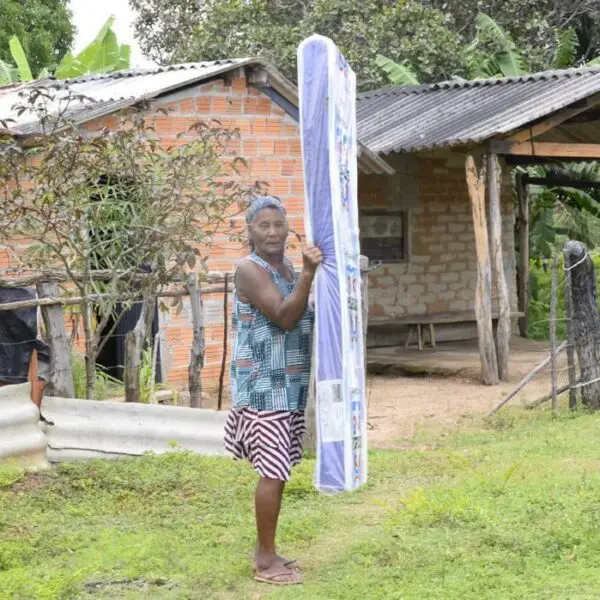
(0, 86, 252, 399)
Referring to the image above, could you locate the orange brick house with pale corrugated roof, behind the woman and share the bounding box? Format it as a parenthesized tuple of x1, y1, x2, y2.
(0, 59, 392, 392)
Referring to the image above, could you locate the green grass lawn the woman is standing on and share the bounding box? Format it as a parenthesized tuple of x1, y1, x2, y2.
(0, 411, 600, 600)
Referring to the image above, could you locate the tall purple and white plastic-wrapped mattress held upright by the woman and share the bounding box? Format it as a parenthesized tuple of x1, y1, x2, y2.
(298, 35, 367, 492)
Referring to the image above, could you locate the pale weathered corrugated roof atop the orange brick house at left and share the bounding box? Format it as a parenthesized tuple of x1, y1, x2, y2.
(0, 58, 254, 135)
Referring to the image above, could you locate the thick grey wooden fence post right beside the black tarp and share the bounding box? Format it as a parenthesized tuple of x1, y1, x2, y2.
(36, 283, 75, 398)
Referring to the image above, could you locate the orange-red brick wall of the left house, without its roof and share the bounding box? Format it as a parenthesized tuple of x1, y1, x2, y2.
(135, 73, 304, 401)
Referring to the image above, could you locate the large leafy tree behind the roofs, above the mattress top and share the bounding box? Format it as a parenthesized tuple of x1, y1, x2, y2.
(130, 0, 462, 89)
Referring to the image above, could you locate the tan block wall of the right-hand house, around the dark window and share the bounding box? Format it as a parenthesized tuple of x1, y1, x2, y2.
(359, 152, 517, 332)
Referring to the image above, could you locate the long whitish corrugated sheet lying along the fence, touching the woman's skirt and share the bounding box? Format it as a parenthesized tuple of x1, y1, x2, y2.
(41, 397, 227, 462)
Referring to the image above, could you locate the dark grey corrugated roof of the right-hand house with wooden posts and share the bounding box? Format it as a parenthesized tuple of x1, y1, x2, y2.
(357, 68, 600, 154)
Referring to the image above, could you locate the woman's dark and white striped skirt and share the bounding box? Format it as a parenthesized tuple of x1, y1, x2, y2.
(225, 408, 306, 481)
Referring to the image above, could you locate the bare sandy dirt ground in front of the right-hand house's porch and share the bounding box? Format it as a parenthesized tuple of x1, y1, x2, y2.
(367, 340, 567, 447)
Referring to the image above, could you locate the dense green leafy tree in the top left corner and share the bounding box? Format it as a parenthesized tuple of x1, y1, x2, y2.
(0, 0, 75, 73)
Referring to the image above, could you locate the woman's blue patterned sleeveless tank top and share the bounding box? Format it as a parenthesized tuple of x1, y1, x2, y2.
(231, 254, 314, 410)
